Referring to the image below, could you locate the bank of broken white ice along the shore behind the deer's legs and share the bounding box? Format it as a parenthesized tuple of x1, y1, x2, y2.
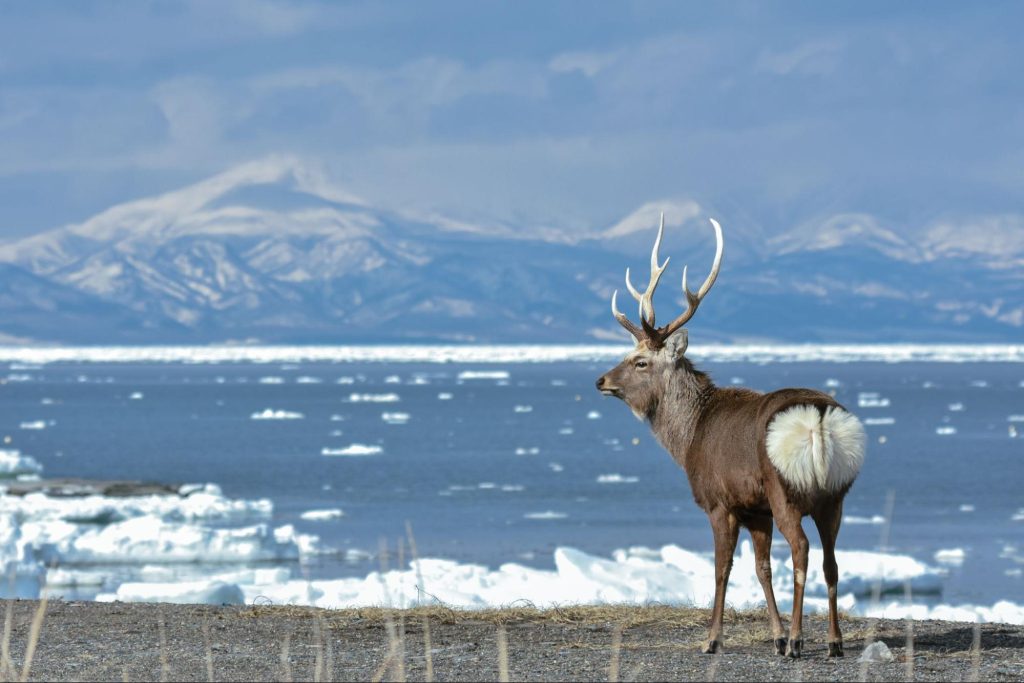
(90, 542, 974, 623)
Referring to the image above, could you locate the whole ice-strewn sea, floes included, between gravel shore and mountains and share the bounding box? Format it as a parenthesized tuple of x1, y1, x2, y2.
(0, 346, 1024, 620)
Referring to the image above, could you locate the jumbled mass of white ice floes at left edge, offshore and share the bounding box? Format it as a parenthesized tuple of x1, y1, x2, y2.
(0, 452, 303, 597)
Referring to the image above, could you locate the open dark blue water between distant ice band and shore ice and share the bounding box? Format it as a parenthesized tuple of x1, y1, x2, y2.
(0, 362, 1024, 604)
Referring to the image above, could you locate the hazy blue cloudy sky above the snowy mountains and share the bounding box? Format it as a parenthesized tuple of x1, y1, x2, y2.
(0, 0, 1024, 238)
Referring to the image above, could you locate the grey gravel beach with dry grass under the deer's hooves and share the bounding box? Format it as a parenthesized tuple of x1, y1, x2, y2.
(2, 600, 1024, 681)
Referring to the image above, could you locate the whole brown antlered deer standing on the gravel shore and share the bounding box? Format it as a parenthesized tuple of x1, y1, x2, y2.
(597, 213, 865, 658)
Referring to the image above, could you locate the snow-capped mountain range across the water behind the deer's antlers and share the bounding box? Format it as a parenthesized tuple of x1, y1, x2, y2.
(0, 157, 1024, 343)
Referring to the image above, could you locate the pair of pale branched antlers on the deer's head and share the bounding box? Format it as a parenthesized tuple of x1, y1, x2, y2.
(611, 212, 725, 346)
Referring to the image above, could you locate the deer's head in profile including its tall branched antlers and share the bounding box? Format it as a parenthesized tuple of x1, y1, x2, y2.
(597, 213, 724, 419)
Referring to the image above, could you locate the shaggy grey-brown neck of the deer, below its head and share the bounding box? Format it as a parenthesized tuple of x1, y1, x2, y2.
(647, 359, 716, 471)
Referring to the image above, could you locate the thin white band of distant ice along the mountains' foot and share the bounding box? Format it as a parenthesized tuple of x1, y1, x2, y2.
(0, 344, 1024, 366)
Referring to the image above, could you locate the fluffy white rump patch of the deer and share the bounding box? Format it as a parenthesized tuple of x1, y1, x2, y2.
(766, 405, 865, 493)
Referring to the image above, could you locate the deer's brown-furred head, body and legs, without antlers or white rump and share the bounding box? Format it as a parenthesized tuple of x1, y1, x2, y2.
(597, 329, 850, 656)
